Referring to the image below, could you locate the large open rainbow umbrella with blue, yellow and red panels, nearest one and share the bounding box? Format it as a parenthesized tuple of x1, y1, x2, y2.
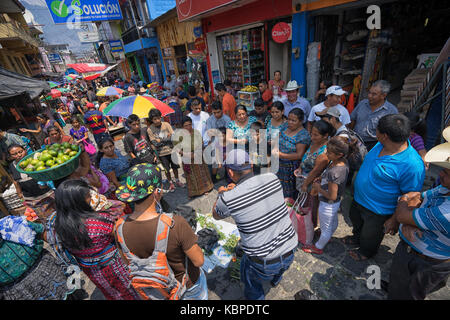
(103, 95, 175, 119)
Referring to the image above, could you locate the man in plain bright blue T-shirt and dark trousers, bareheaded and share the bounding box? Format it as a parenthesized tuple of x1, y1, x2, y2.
(343, 114, 425, 261)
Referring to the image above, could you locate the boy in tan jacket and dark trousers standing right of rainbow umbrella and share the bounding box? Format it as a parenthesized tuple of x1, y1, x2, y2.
(147, 109, 184, 192)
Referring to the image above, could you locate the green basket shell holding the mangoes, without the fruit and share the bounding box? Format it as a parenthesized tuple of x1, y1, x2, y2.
(16, 148, 81, 181)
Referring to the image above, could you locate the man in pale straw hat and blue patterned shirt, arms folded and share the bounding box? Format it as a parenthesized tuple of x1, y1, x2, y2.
(385, 127, 450, 300)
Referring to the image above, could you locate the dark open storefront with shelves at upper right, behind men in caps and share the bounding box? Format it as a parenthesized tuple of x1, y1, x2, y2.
(307, 0, 450, 107)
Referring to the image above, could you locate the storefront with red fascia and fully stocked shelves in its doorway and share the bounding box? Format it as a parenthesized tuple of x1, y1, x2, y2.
(178, 0, 292, 96)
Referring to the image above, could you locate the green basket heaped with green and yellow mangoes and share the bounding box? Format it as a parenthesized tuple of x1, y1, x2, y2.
(17, 142, 81, 181)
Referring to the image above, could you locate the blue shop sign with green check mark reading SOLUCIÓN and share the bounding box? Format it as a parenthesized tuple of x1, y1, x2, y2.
(45, 0, 123, 23)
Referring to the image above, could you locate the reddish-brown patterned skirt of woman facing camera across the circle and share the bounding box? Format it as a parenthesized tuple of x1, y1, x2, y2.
(183, 163, 214, 197)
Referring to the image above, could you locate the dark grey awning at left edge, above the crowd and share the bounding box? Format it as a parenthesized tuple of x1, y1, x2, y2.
(0, 67, 50, 99)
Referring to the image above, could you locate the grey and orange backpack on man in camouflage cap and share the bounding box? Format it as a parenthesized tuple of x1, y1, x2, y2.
(114, 213, 187, 300)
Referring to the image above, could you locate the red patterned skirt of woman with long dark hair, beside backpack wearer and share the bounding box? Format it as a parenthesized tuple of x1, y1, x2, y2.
(82, 255, 139, 300)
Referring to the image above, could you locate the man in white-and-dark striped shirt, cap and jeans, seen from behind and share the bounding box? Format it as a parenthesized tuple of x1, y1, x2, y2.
(213, 149, 298, 300)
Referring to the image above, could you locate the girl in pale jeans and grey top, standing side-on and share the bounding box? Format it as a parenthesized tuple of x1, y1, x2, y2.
(302, 136, 355, 254)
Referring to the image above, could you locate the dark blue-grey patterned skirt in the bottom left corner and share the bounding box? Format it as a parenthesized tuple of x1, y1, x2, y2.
(0, 249, 69, 300)
